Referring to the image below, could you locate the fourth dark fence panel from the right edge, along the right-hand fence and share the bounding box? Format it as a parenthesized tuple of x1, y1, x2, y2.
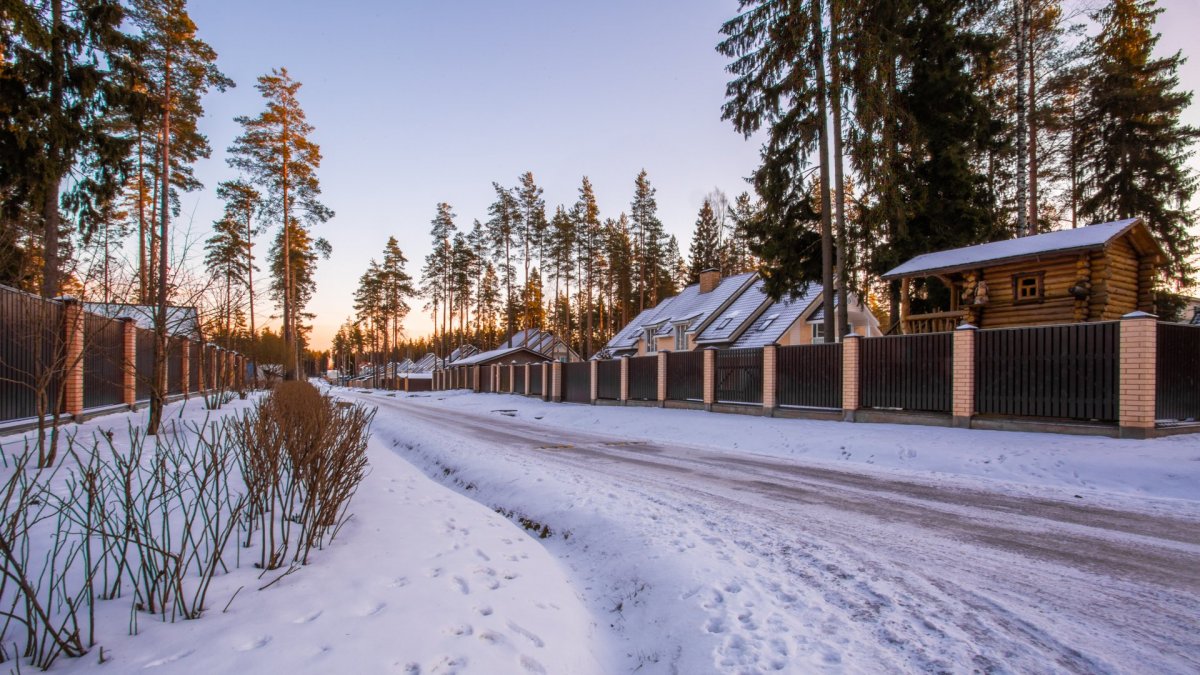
(775, 342, 841, 408)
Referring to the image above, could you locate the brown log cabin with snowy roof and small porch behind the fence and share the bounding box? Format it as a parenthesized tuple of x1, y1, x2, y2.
(883, 217, 1166, 334)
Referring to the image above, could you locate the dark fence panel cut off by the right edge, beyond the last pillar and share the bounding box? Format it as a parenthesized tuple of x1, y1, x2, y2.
(1154, 323, 1200, 420)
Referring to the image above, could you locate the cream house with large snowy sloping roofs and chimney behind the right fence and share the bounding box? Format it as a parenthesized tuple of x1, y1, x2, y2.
(599, 270, 881, 358)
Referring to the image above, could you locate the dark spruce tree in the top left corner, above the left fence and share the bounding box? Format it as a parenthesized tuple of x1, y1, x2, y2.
(0, 0, 144, 297)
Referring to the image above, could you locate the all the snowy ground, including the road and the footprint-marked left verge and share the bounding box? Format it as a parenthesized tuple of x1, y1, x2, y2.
(11, 389, 1200, 675)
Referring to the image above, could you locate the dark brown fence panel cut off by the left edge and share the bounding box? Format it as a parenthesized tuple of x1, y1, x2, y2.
(0, 286, 64, 420)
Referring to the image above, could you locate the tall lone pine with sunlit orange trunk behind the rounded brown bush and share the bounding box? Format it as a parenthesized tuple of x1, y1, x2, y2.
(228, 68, 334, 380)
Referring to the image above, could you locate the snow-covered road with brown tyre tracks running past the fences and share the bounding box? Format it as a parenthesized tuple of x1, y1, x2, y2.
(350, 392, 1200, 673)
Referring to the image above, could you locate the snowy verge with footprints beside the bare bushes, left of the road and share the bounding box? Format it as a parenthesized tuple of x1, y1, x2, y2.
(0, 400, 605, 675)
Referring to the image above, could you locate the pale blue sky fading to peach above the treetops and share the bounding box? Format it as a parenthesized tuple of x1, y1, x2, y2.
(180, 0, 1200, 348)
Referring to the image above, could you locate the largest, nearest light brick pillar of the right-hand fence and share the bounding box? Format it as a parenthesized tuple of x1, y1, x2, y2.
(1117, 312, 1158, 438)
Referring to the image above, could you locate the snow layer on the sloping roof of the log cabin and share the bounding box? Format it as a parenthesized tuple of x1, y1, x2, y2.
(883, 217, 1141, 279)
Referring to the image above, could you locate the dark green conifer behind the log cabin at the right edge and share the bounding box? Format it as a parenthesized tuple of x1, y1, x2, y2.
(1079, 0, 1200, 287)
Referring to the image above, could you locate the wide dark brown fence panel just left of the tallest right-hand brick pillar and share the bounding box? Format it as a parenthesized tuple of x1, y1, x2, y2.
(976, 322, 1121, 422)
